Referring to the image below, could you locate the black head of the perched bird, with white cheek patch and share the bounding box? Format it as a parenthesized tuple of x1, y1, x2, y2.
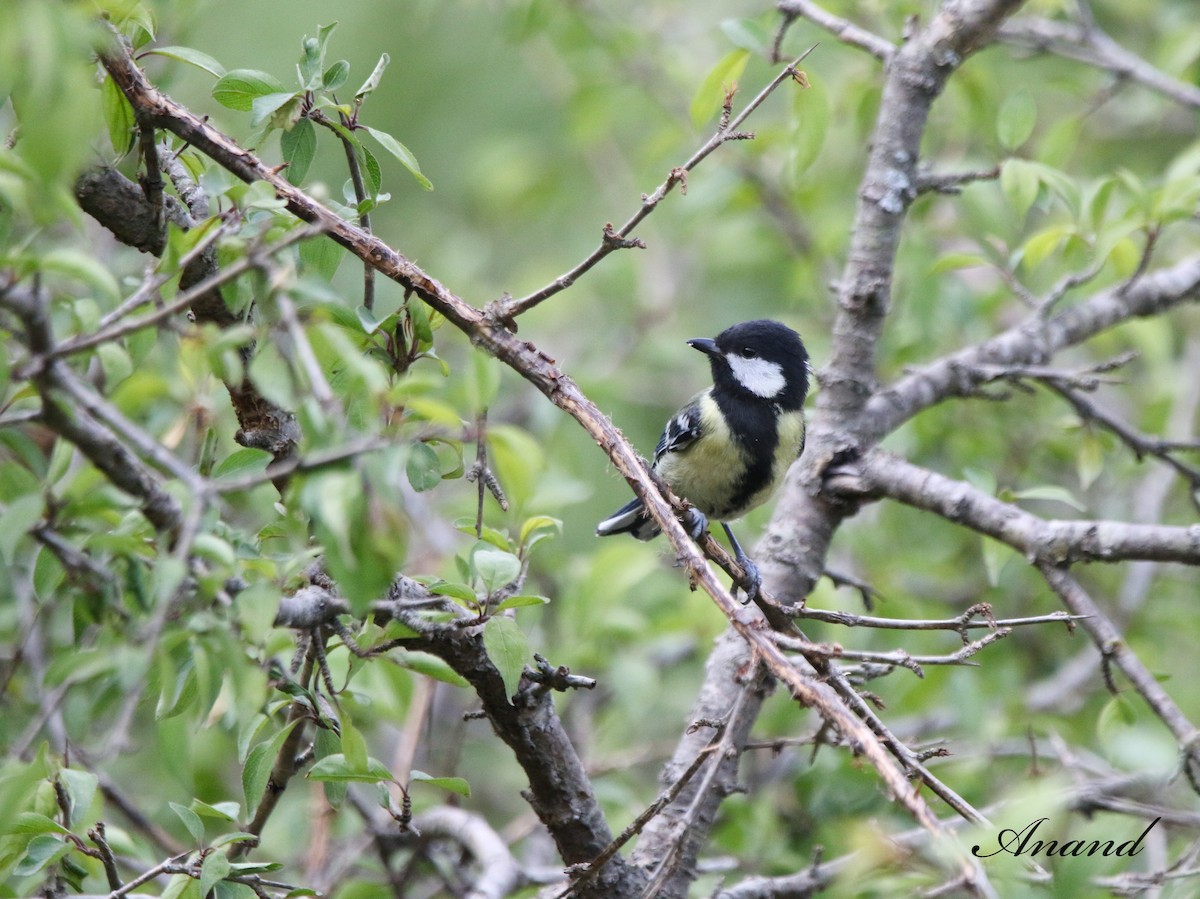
(688, 318, 809, 409)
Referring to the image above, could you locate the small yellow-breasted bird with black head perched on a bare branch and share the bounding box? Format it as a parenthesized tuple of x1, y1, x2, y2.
(596, 318, 811, 603)
